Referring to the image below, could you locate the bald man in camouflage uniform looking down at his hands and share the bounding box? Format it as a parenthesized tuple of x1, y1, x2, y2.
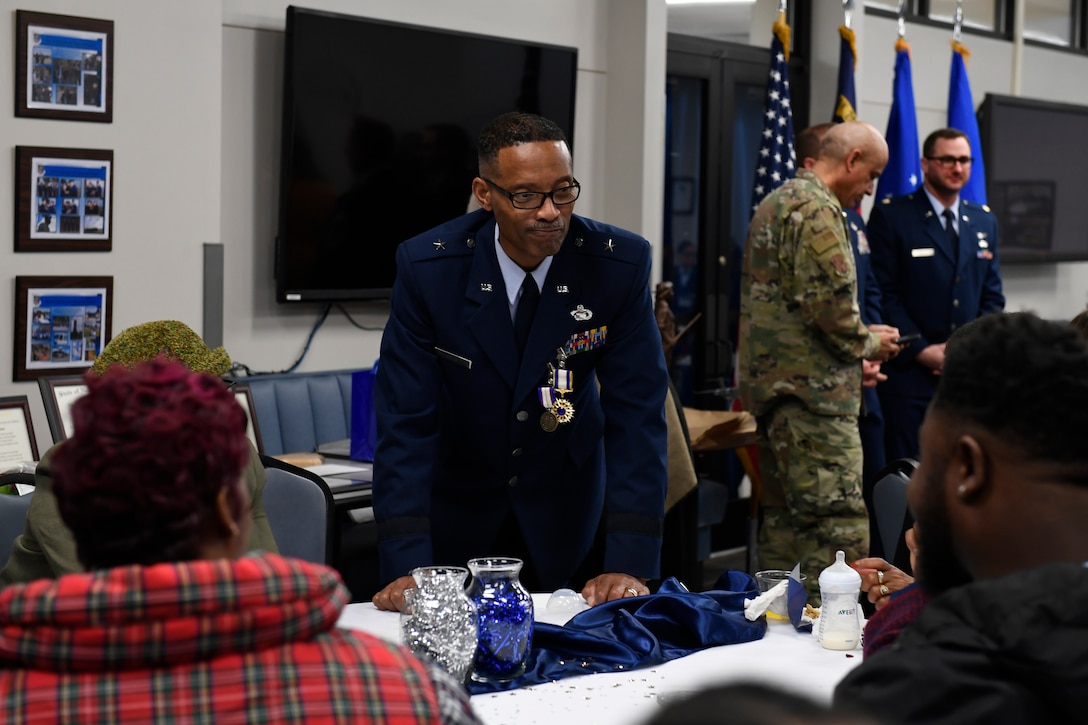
(739, 122, 900, 601)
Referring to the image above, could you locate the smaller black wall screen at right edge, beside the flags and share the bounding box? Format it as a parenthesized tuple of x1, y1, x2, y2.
(978, 94, 1088, 265)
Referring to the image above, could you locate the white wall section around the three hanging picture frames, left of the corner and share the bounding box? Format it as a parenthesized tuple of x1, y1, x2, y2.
(0, 0, 222, 451)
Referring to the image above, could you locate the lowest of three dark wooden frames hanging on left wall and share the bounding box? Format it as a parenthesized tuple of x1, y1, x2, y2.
(12, 277, 113, 382)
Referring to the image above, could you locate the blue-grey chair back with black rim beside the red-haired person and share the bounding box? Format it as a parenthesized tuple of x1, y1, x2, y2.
(261, 455, 335, 565)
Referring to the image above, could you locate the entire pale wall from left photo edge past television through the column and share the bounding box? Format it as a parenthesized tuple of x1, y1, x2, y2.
(0, 0, 666, 450)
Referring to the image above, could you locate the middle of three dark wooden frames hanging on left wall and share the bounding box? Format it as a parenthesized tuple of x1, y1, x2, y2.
(14, 146, 113, 251)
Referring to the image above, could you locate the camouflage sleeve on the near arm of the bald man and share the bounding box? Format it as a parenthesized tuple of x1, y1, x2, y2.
(794, 206, 880, 361)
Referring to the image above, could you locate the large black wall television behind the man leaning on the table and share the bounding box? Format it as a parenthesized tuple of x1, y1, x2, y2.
(275, 7, 578, 303)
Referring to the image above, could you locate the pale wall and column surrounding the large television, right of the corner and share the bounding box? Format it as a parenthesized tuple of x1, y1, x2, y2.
(222, 0, 665, 371)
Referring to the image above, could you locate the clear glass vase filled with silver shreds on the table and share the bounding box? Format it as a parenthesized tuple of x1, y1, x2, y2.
(400, 566, 477, 681)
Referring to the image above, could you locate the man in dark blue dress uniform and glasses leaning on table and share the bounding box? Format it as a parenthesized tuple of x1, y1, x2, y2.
(373, 112, 668, 610)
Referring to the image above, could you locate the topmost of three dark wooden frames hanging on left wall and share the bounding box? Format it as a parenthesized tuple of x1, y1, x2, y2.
(15, 10, 113, 123)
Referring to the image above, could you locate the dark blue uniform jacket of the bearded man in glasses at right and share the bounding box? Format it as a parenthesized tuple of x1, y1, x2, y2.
(868, 187, 1005, 398)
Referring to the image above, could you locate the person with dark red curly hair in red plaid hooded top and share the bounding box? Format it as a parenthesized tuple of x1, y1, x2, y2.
(0, 358, 479, 725)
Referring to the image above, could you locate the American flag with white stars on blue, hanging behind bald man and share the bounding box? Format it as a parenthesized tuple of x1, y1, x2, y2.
(750, 13, 798, 216)
